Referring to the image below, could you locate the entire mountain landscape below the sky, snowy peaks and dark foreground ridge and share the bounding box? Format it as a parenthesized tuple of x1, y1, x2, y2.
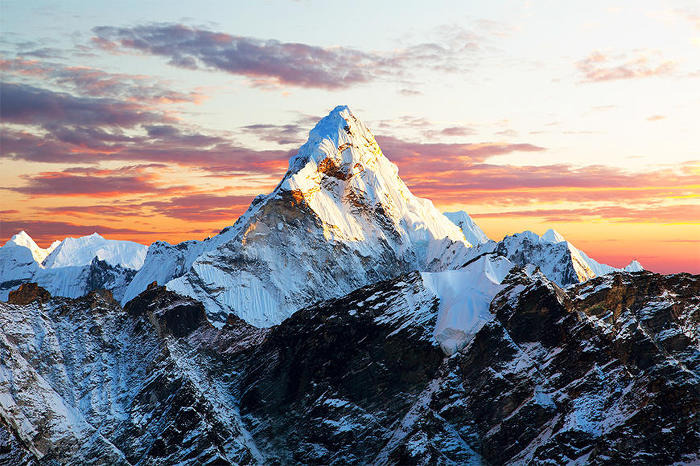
(0, 106, 700, 465)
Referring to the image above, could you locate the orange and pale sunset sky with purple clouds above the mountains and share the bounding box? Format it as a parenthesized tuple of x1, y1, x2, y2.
(0, 0, 700, 273)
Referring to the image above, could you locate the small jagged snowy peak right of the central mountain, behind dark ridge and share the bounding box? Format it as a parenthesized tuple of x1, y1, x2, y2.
(496, 229, 644, 286)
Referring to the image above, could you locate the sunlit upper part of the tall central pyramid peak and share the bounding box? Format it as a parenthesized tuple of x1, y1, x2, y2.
(278, 106, 465, 251)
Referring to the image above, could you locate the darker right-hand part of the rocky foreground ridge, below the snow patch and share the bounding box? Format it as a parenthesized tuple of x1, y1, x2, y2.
(235, 271, 700, 464)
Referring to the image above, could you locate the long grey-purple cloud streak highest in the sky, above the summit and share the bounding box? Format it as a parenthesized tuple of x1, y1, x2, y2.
(93, 23, 478, 89)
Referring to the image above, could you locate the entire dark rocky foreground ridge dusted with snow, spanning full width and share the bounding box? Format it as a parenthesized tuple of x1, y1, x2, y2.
(0, 270, 700, 464)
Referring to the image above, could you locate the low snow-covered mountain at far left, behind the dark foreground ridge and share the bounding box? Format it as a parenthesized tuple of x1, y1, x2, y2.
(0, 231, 146, 300)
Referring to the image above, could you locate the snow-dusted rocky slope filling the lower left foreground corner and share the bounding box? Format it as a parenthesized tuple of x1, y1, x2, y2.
(0, 290, 257, 464)
